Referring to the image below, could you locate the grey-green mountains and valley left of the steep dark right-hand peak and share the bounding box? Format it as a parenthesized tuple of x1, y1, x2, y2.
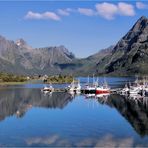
(0, 36, 113, 76)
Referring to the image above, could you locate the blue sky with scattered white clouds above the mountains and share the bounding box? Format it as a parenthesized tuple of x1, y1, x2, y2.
(0, 0, 148, 57)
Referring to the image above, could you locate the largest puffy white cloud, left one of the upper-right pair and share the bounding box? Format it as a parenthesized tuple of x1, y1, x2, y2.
(96, 2, 118, 20)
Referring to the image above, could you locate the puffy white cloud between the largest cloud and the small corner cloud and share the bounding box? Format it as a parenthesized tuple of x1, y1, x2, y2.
(118, 2, 135, 16)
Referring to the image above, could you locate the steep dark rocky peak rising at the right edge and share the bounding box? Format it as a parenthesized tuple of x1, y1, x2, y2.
(96, 16, 148, 75)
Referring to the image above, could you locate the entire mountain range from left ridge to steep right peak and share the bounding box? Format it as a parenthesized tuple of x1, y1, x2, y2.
(0, 16, 148, 76)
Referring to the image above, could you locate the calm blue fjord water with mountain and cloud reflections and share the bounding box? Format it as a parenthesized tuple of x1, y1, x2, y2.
(0, 78, 148, 147)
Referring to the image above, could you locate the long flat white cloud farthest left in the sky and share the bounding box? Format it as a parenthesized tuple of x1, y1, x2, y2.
(25, 11, 60, 21)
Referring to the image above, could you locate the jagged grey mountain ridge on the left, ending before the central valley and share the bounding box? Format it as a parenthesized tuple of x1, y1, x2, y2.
(0, 36, 75, 74)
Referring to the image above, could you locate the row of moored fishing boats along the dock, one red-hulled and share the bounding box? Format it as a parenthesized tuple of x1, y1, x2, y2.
(41, 77, 148, 96)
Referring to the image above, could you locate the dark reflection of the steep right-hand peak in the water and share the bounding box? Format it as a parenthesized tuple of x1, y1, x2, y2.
(98, 95, 148, 136)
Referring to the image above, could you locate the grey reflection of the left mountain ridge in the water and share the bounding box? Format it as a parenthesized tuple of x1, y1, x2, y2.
(0, 89, 73, 121)
